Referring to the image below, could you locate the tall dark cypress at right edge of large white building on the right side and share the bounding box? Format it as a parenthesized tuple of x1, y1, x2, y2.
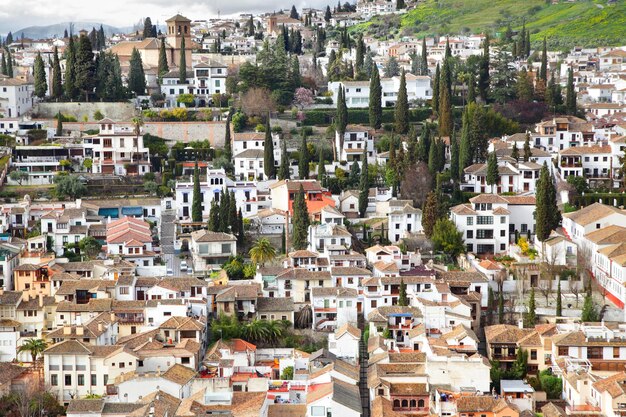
(535, 163, 561, 242)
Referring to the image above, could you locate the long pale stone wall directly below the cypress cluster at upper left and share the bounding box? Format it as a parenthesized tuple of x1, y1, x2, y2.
(32, 103, 135, 121)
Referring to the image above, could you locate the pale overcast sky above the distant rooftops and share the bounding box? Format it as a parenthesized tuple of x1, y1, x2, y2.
(0, 0, 336, 34)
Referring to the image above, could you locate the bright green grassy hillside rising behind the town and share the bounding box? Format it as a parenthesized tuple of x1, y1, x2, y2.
(354, 0, 626, 48)
